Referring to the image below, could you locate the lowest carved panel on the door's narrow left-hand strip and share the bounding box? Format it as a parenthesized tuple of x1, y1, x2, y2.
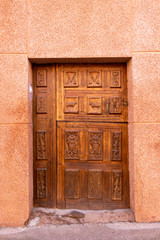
(37, 168, 47, 199)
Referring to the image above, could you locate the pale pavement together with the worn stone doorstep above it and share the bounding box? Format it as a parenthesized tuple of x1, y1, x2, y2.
(0, 208, 160, 240)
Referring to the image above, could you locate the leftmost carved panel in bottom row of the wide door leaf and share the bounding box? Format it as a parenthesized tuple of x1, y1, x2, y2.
(65, 170, 80, 198)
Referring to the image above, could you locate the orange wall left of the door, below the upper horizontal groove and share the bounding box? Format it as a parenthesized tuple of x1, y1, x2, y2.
(0, 54, 33, 226)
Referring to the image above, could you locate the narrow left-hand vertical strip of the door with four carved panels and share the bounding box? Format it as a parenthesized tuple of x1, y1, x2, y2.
(33, 65, 56, 207)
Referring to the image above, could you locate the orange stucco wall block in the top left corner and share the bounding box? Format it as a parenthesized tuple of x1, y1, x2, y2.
(0, 0, 28, 53)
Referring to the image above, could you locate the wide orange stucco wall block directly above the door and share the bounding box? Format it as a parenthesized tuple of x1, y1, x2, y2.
(29, 0, 131, 58)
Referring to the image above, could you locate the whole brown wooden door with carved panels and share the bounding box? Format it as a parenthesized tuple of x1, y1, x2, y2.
(34, 64, 129, 209)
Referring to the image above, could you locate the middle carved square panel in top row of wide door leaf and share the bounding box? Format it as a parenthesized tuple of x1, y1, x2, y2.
(87, 71, 102, 87)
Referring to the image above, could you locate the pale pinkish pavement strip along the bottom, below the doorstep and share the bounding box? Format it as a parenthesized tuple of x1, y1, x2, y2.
(0, 222, 160, 240)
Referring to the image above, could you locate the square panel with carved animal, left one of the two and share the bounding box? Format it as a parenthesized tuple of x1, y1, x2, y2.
(64, 97, 79, 113)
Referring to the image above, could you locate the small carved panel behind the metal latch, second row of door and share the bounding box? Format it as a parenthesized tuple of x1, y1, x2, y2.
(109, 97, 122, 114)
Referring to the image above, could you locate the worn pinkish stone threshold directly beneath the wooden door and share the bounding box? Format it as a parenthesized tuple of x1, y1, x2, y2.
(26, 208, 135, 227)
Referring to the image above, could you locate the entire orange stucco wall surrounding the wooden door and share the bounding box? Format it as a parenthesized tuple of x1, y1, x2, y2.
(0, 0, 160, 226)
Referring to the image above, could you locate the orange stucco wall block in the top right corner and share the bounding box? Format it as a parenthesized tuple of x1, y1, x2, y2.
(133, 0, 160, 52)
